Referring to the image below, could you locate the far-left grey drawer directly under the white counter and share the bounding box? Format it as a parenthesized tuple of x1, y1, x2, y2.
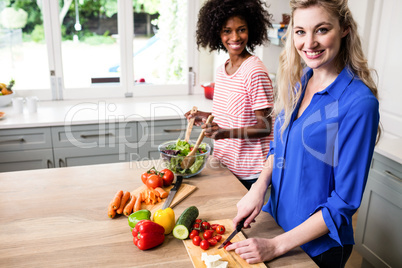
(0, 128, 52, 152)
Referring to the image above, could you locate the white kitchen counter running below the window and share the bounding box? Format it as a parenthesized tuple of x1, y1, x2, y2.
(0, 95, 212, 129)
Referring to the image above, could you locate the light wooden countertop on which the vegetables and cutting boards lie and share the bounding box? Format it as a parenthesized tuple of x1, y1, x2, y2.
(0, 157, 315, 268)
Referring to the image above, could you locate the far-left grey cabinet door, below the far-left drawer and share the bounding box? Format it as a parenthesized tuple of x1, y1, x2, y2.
(0, 149, 54, 172)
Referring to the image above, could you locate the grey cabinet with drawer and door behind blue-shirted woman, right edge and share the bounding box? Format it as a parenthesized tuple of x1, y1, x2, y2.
(356, 153, 402, 267)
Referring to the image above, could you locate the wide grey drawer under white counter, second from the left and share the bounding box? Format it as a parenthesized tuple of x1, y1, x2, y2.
(52, 122, 137, 149)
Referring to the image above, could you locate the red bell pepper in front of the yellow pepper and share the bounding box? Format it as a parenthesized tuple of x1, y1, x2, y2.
(132, 220, 165, 250)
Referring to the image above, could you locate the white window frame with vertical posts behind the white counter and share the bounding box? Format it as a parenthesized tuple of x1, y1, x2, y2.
(18, 0, 199, 100)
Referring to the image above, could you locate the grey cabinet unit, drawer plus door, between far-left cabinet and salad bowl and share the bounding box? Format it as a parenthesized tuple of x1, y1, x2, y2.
(52, 122, 138, 167)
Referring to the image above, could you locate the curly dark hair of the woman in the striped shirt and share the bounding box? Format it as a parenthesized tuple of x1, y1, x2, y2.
(196, 0, 272, 52)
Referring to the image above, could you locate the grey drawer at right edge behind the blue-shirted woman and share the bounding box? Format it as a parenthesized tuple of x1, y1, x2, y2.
(370, 153, 402, 182)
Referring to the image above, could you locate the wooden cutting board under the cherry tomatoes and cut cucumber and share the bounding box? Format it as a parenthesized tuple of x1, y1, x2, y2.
(183, 219, 267, 268)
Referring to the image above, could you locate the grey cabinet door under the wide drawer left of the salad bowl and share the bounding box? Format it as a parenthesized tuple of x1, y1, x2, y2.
(54, 146, 139, 167)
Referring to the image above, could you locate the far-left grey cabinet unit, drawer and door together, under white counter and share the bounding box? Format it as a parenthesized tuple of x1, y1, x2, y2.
(0, 127, 55, 172)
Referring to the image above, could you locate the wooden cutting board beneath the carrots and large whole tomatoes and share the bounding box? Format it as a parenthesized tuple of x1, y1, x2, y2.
(131, 183, 197, 213)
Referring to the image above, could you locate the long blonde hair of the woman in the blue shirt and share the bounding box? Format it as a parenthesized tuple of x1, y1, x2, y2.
(275, 0, 381, 137)
